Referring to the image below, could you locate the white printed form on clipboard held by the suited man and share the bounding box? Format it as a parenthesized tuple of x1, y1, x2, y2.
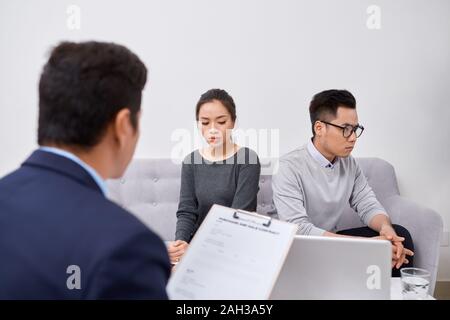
(167, 205, 297, 300)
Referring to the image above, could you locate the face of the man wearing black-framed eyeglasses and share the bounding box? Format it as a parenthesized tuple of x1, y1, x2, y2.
(320, 107, 358, 158)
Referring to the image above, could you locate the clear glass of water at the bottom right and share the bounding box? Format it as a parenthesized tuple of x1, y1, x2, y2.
(400, 268, 431, 300)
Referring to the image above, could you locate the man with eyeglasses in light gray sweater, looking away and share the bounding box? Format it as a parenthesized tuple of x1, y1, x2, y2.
(272, 90, 414, 276)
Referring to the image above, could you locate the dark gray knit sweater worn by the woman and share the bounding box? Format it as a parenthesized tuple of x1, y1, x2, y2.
(175, 147, 261, 242)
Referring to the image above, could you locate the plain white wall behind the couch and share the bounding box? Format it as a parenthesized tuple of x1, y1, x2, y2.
(0, 0, 450, 280)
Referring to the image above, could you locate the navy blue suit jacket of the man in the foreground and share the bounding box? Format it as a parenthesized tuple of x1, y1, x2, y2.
(0, 150, 170, 299)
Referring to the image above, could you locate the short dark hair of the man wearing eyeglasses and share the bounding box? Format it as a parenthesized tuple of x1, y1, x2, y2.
(309, 89, 356, 135)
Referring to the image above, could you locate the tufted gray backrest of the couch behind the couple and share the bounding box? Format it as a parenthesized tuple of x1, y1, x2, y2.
(108, 158, 399, 240)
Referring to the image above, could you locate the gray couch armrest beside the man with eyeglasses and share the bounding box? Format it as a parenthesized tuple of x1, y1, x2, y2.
(383, 195, 443, 294)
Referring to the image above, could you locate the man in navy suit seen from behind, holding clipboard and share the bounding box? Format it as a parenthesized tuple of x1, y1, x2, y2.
(0, 42, 170, 299)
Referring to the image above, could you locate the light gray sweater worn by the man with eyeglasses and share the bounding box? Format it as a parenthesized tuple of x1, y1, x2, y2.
(272, 143, 387, 235)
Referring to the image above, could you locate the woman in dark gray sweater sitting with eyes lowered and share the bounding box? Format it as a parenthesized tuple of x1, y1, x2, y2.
(168, 89, 261, 263)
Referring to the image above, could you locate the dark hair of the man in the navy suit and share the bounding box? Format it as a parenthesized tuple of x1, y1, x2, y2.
(38, 41, 147, 148)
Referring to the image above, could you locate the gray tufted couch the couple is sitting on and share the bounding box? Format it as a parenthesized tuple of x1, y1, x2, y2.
(108, 158, 443, 292)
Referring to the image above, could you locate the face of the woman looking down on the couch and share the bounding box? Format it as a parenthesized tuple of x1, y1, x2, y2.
(198, 100, 234, 147)
